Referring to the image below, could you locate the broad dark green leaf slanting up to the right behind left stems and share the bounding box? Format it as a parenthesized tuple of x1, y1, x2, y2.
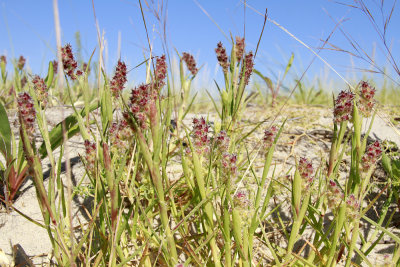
(39, 101, 98, 159)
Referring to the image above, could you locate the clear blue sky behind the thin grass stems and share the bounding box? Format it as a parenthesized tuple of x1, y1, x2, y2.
(0, 0, 400, 91)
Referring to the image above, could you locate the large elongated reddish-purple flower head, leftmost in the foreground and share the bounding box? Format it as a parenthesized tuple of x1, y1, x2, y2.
(17, 92, 36, 142)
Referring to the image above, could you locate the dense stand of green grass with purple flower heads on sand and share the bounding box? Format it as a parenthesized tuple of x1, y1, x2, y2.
(0, 1, 400, 267)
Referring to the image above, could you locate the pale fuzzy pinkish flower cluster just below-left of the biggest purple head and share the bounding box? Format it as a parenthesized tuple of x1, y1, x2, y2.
(109, 120, 133, 153)
